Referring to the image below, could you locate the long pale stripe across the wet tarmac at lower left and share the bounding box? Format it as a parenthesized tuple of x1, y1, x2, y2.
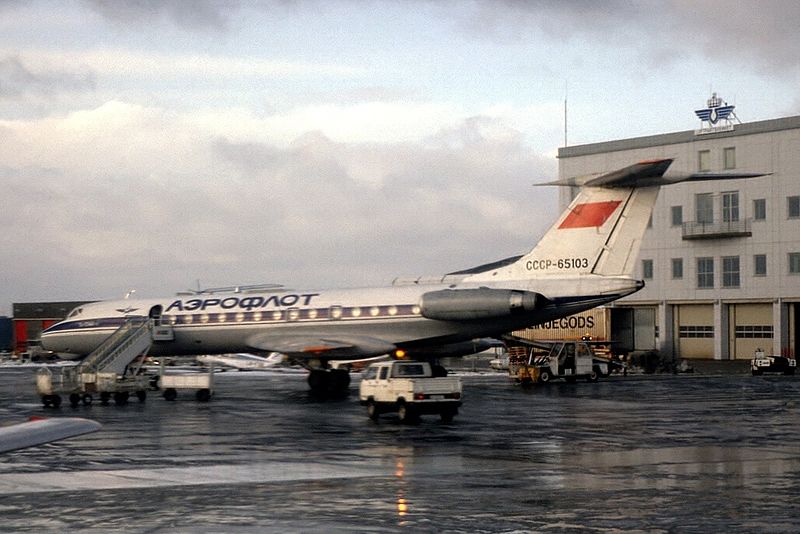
(0, 462, 384, 495)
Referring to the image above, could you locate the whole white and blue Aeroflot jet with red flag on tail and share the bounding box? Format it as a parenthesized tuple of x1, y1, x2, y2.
(41, 159, 763, 390)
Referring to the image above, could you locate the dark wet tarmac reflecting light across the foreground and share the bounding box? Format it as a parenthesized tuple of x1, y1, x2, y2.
(0, 369, 800, 532)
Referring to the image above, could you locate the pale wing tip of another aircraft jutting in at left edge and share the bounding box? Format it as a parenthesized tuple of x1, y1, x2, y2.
(0, 417, 101, 452)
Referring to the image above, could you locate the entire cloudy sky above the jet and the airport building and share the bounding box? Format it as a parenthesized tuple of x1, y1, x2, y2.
(0, 0, 800, 314)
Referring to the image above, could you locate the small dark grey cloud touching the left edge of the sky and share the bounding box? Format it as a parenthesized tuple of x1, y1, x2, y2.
(0, 55, 96, 100)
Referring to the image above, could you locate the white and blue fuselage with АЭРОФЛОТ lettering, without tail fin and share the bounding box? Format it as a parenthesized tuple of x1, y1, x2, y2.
(42, 276, 641, 357)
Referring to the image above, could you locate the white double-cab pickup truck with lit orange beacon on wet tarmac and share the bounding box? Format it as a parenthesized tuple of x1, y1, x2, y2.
(359, 361, 462, 423)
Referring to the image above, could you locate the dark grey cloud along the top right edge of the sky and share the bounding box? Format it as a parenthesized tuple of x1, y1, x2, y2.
(456, 0, 800, 76)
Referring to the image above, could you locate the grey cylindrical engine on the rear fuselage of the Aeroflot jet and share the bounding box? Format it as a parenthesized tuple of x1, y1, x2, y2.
(419, 287, 547, 321)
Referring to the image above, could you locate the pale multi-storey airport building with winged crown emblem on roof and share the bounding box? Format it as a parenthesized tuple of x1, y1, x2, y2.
(558, 95, 800, 360)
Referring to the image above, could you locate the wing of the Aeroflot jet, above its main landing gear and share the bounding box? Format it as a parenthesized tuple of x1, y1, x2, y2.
(247, 334, 396, 360)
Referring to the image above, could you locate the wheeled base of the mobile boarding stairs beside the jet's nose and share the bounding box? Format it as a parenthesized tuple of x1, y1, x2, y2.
(36, 367, 149, 408)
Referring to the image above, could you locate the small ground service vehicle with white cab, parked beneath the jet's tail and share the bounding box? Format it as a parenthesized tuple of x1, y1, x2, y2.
(512, 341, 608, 386)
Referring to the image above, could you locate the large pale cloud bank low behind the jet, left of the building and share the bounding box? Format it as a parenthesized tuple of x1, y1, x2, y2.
(0, 117, 556, 302)
